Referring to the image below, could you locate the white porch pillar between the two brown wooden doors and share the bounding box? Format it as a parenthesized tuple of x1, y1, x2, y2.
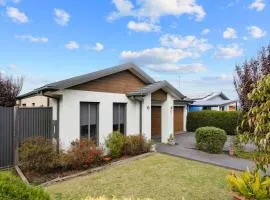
(161, 94, 174, 143)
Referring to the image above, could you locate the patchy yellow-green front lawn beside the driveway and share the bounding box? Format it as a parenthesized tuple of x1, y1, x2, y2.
(47, 154, 231, 200)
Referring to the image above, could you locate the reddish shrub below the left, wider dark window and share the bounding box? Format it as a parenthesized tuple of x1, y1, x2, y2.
(65, 139, 103, 169)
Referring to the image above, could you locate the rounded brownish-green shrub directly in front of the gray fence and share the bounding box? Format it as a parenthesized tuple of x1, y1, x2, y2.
(19, 137, 60, 173)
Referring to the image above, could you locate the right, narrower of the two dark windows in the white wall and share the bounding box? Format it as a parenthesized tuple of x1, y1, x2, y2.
(113, 103, 126, 134)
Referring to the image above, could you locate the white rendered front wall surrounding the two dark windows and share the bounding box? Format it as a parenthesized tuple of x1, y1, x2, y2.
(59, 90, 140, 148)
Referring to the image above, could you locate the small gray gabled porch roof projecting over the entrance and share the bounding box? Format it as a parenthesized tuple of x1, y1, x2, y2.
(127, 81, 185, 99)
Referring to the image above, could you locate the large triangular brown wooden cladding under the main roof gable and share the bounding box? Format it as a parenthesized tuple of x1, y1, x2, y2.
(69, 70, 146, 94)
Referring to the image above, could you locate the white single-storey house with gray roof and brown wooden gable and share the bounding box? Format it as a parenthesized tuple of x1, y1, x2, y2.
(18, 63, 189, 148)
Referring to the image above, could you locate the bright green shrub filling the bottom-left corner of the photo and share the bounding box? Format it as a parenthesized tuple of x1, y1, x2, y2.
(0, 172, 50, 200)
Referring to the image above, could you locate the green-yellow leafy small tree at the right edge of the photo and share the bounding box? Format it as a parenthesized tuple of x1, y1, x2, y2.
(243, 74, 270, 169)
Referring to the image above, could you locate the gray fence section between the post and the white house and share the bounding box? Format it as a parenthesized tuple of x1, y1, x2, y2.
(17, 108, 53, 142)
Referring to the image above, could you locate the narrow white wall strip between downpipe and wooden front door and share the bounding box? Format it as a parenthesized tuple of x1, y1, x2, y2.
(142, 94, 152, 139)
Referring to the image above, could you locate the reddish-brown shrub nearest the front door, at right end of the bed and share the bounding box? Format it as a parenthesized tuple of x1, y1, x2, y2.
(124, 135, 151, 156)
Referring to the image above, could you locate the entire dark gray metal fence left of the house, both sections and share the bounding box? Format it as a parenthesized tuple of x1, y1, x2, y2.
(0, 107, 53, 168)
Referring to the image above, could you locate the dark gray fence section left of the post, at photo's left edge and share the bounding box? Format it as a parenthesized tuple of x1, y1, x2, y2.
(0, 107, 14, 168)
